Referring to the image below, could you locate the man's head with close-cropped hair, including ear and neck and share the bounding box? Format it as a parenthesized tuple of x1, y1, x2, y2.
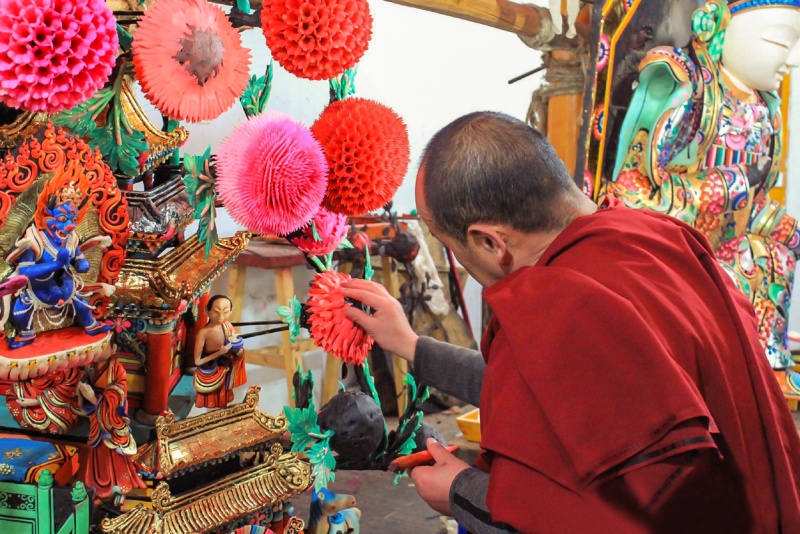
(416, 112, 595, 287)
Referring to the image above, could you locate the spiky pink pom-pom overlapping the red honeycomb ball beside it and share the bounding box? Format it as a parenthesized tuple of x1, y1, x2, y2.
(216, 111, 327, 235)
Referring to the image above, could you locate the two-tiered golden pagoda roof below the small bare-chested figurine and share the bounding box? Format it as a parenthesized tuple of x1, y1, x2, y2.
(102, 386, 312, 534)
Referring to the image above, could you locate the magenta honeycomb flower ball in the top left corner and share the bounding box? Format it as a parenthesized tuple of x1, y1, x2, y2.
(0, 0, 119, 113)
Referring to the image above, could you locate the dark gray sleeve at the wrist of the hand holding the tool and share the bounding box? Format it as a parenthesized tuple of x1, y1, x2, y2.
(450, 468, 518, 534)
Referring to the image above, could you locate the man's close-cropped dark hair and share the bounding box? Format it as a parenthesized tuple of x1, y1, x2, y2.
(422, 111, 579, 242)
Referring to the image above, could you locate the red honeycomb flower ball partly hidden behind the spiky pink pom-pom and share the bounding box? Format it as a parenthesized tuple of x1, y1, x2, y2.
(311, 97, 409, 216)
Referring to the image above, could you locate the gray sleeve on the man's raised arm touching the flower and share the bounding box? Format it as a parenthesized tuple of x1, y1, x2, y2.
(414, 336, 486, 406)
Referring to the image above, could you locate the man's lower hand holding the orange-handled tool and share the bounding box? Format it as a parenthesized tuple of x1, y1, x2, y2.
(409, 438, 469, 516)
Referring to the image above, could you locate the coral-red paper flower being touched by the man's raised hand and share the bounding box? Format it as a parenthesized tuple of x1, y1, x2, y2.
(308, 271, 374, 365)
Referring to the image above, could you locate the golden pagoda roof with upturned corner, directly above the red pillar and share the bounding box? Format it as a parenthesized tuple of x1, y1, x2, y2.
(108, 232, 248, 317)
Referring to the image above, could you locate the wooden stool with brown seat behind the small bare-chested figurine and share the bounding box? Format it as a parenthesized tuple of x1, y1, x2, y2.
(228, 240, 341, 406)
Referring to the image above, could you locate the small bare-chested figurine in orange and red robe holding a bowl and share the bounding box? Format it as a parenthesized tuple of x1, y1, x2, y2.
(194, 295, 247, 408)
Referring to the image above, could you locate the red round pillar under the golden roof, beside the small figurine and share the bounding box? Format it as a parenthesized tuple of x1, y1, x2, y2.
(142, 323, 174, 416)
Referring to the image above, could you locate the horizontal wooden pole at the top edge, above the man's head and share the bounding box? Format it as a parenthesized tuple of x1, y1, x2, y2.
(388, 0, 550, 37)
